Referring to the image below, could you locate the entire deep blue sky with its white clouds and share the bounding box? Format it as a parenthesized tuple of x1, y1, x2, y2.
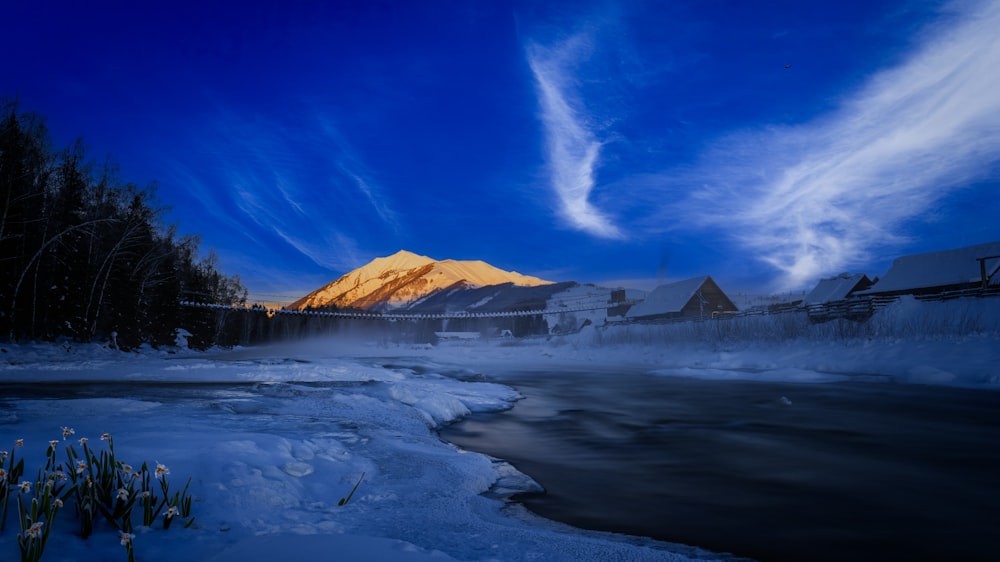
(0, 0, 1000, 300)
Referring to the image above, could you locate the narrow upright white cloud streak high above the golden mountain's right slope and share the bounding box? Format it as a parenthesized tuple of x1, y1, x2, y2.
(527, 34, 623, 239)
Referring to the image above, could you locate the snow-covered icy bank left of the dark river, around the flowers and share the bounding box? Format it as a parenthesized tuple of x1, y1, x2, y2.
(0, 336, 736, 562)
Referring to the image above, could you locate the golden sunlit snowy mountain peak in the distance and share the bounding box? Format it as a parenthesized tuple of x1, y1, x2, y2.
(286, 250, 551, 310)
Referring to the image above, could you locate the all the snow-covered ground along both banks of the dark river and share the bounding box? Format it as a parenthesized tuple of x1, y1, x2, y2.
(0, 299, 1000, 562)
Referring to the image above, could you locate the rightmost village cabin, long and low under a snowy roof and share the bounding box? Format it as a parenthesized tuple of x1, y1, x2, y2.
(855, 238, 1000, 296)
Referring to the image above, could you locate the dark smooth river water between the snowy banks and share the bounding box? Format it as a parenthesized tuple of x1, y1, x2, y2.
(441, 372, 1000, 561)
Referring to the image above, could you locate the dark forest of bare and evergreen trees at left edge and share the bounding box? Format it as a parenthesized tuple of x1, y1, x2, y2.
(0, 102, 247, 349)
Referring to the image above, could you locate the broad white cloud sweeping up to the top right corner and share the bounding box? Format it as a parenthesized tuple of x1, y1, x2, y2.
(685, 2, 1000, 288)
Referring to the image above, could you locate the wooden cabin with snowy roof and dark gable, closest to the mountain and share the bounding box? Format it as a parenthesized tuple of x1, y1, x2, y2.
(625, 275, 737, 322)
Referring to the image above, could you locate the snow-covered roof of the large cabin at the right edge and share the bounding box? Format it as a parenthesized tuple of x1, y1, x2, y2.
(858, 242, 1000, 294)
